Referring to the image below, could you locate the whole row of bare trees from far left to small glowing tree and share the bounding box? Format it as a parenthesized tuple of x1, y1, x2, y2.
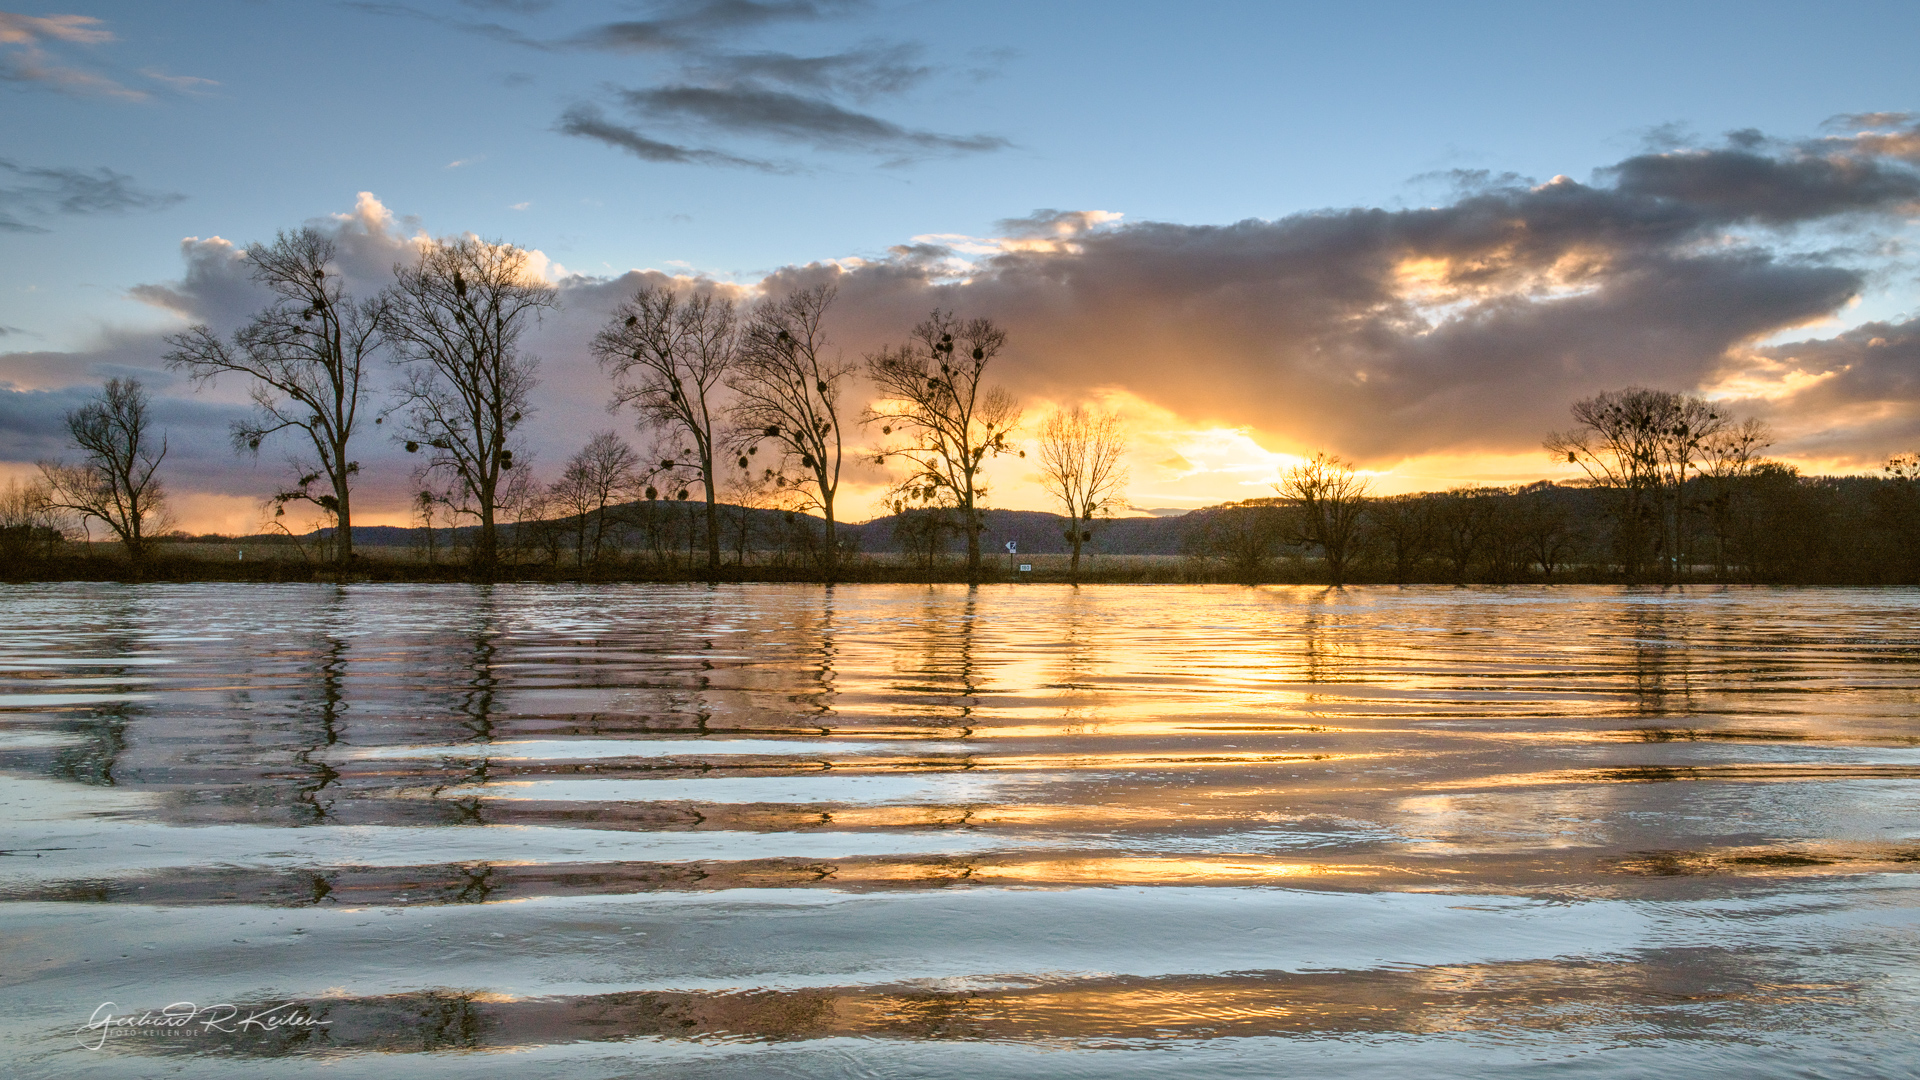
(40, 220, 1125, 580)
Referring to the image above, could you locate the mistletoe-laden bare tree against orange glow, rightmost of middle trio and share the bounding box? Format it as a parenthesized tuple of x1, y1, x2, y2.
(862, 309, 1027, 584)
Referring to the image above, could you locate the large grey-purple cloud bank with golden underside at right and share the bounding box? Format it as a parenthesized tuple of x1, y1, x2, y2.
(744, 122, 1920, 465)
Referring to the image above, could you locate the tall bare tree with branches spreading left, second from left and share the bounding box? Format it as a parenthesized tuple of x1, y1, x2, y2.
(167, 229, 380, 563)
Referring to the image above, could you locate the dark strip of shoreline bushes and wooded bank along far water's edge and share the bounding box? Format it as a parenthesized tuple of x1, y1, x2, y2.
(11, 469, 1920, 586)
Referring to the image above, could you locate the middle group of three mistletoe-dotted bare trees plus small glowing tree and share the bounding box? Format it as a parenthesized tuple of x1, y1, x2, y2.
(563, 286, 1125, 580)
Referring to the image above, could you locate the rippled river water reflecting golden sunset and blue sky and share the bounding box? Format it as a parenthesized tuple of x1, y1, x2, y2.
(0, 584, 1920, 1080)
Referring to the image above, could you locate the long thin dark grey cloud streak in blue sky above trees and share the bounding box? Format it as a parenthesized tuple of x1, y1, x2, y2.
(620, 85, 1010, 154)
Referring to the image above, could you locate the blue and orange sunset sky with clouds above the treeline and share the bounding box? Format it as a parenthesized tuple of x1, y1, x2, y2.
(0, 0, 1920, 532)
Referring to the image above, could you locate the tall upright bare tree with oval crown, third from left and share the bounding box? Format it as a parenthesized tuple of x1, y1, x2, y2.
(380, 236, 559, 569)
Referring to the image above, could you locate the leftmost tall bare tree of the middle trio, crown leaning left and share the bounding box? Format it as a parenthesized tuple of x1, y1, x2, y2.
(593, 284, 739, 575)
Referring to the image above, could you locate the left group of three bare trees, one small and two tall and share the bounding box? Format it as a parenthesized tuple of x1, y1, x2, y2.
(36, 229, 557, 567)
